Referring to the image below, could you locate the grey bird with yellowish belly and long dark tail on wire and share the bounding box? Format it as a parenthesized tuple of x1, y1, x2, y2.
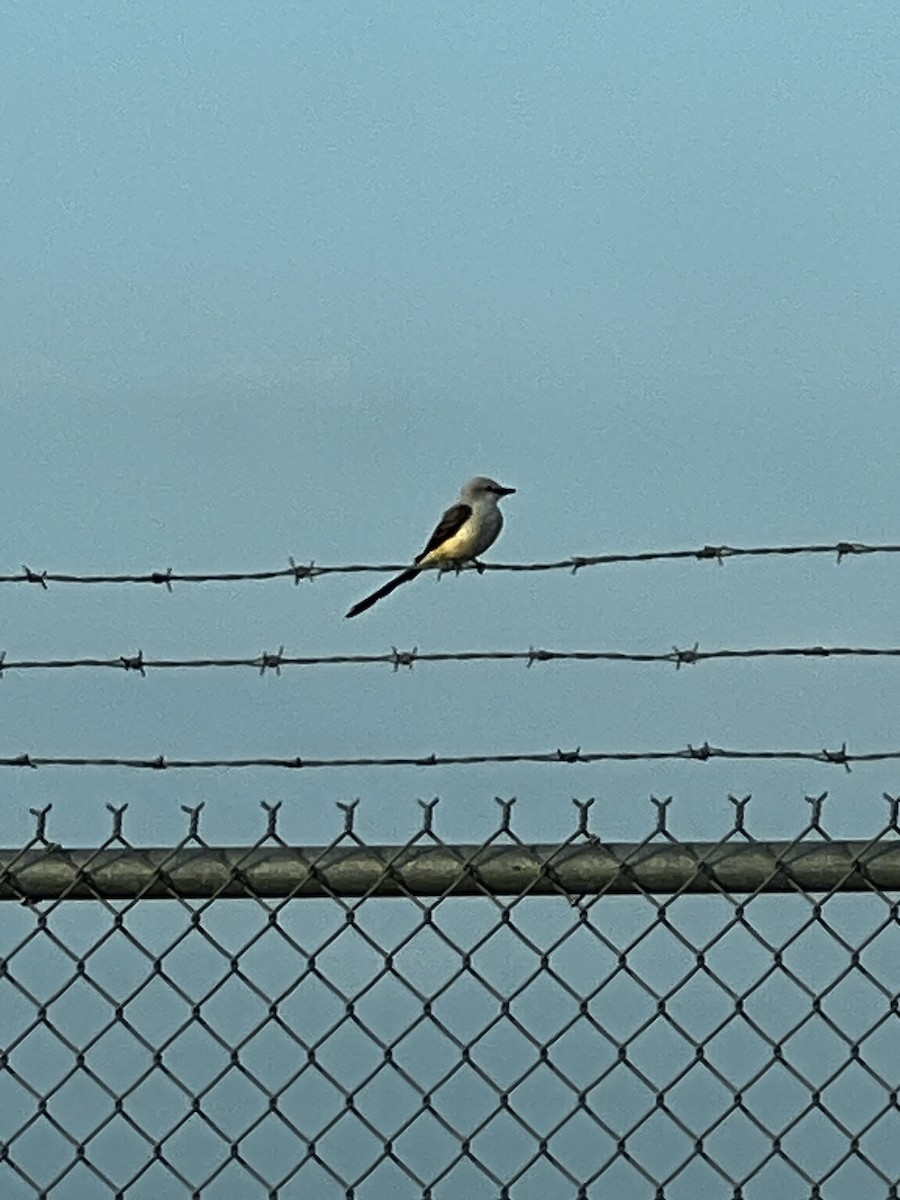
(347, 475, 515, 617)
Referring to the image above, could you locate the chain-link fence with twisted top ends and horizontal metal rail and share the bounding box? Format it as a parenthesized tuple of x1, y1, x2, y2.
(0, 797, 900, 1200)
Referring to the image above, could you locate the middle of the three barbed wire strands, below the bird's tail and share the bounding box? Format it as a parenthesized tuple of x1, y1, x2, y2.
(8, 642, 900, 678)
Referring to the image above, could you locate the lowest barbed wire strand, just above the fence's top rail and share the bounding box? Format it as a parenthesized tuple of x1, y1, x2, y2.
(0, 742, 900, 772)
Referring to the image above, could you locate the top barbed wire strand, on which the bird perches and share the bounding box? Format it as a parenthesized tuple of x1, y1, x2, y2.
(0, 541, 900, 592)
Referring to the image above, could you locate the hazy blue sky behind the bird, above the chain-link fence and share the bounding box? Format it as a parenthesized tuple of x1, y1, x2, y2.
(0, 0, 900, 1196)
